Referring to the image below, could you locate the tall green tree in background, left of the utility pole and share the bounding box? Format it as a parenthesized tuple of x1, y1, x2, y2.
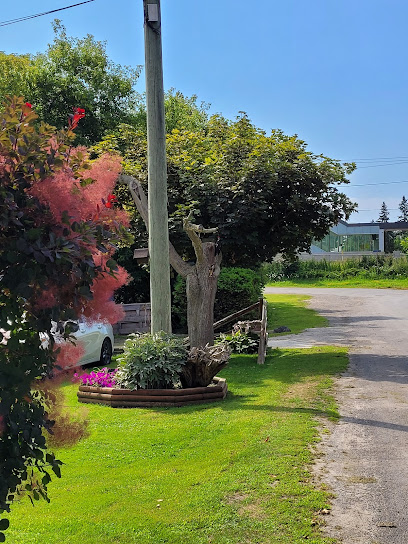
(21, 20, 140, 145)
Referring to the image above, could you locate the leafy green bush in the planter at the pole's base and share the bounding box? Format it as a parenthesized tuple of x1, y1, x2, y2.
(115, 332, 187, 389)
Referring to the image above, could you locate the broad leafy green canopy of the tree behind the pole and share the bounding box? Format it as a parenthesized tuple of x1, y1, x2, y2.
(99, 113, 355, 267)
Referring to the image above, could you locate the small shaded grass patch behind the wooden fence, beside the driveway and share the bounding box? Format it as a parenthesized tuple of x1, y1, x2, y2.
(264, 294, 328, 336)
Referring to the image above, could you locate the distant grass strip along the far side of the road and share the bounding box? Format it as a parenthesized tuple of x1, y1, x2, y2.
(268, 277, 408, 289)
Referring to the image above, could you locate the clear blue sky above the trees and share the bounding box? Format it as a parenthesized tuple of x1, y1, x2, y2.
(0, 0, 408, 221)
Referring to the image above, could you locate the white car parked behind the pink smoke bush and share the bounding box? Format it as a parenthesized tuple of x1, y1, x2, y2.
(46, 320, 114, 366)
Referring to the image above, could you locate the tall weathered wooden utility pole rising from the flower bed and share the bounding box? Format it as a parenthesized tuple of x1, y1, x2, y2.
(143, 0, 171, 333)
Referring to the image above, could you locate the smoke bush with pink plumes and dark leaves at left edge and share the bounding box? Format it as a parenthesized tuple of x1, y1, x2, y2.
(0, 97, 128, 541)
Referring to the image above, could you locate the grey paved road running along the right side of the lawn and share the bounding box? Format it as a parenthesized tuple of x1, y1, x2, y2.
(266, 288, 408, 544)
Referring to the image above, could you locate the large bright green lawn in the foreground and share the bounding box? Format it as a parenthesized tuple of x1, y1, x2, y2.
(7, 347, 347, 544)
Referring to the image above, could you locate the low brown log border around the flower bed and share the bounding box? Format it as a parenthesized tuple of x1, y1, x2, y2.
(77, 377, 228, 408)
